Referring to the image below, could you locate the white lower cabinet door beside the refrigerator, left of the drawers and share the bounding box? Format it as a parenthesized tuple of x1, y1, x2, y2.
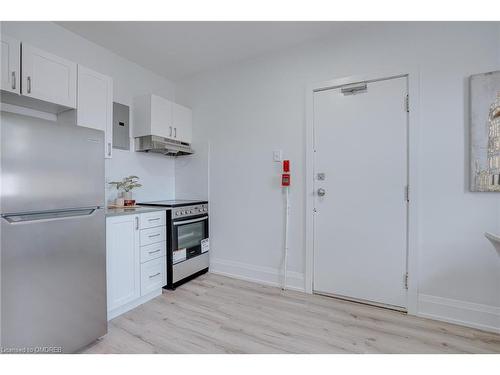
(106, 215, 141, 312)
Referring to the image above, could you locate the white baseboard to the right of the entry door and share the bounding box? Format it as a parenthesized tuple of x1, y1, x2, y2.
(417, 294, 500, 333)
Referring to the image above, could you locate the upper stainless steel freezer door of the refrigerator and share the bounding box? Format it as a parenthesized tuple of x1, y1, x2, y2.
(0, 112, 104, 214)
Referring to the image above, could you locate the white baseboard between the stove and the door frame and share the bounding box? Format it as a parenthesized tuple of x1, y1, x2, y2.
(210, 259, 305, 292)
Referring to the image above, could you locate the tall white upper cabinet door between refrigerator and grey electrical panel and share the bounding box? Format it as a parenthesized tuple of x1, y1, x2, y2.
(76, 65, 113, 158)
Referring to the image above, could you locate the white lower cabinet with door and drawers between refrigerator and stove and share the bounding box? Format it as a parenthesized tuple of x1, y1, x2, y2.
(106, 211, 167, 320)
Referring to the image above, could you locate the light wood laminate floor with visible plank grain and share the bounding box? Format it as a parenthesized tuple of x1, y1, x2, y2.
(83, 274, 500, 353)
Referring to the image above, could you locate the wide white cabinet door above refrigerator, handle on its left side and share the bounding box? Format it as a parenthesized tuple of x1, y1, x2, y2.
(22, 44, 76, 108)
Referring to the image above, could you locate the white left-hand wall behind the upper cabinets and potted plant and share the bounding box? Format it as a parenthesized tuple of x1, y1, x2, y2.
(1, 22, 175, 204)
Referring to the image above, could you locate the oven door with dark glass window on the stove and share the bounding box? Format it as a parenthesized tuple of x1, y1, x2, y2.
(172, 215, 208, 264)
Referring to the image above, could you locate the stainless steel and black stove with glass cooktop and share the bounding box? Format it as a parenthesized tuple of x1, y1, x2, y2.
(140, 200, 210, 289)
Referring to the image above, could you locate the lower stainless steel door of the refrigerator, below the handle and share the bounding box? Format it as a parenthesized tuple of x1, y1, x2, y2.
(0, 209, 107, 353)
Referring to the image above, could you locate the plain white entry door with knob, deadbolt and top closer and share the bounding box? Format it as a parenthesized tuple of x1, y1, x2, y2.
(313, 77, 408, 309)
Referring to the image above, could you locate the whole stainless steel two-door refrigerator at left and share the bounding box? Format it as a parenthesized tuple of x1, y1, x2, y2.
(0, 112, 107, 353)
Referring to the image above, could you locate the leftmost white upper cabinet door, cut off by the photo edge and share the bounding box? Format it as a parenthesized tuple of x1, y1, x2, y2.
(0, 35, 21, 94)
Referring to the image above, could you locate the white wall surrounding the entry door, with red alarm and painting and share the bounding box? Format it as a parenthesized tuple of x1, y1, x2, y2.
(177, 23, 500, 330)
